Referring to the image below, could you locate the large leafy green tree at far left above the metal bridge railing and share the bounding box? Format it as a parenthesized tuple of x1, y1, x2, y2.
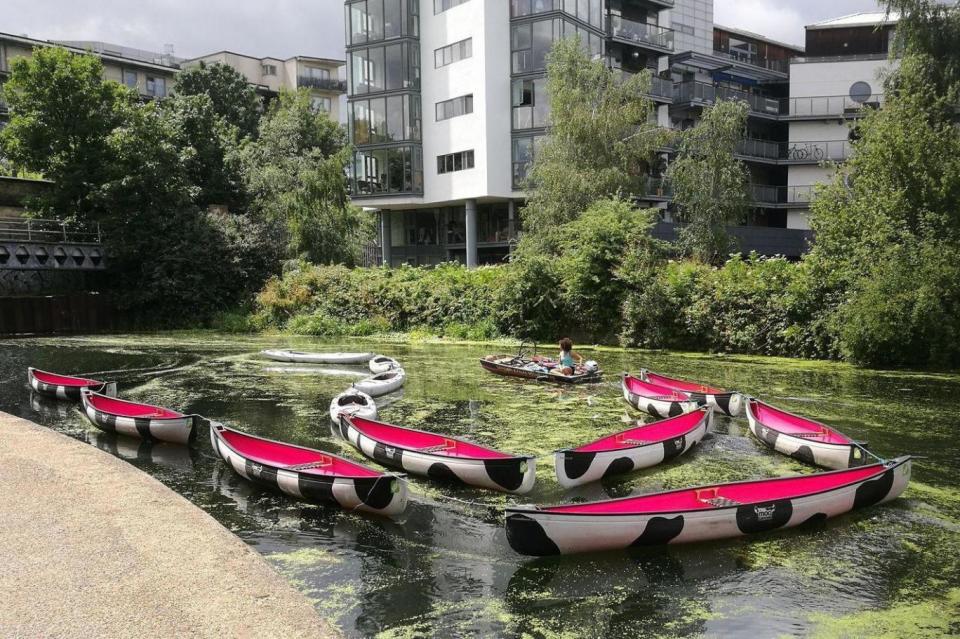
(0, 47, 136, 220)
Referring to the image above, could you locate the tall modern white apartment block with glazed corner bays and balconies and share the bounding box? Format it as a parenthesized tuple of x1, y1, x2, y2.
(345, 0, 892, 266)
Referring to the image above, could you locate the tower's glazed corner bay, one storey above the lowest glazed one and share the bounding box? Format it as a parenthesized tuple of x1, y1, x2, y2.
(349, 94, 421, 145)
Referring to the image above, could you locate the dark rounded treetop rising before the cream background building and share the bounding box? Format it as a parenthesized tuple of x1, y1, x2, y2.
(173, 62, 263, 137)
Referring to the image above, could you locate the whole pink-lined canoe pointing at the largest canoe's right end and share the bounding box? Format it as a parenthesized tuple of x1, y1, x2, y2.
(747, 398, 870, 470)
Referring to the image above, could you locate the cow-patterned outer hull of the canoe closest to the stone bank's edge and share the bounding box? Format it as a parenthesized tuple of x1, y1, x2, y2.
(203, 420, 408, 517)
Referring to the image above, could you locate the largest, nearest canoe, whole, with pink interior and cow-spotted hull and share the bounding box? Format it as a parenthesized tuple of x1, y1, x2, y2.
(506, 457, 910, 556)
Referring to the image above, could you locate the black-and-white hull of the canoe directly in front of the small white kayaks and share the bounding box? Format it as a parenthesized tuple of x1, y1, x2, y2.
(337, 415, 536, 495)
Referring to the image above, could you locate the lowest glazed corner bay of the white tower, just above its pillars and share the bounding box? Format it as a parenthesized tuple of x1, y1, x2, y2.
(350, 146, 423, 195)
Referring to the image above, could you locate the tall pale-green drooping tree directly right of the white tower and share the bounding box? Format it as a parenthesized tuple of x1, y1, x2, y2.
(522, 38, 664, 234)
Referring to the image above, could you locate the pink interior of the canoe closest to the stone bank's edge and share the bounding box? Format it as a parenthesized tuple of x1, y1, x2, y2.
(220, 430, 383, 477)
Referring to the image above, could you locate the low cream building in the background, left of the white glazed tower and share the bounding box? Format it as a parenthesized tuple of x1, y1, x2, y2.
(180, 51, 347, 122)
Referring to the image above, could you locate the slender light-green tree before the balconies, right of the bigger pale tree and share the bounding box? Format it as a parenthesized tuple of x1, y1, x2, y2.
(667, 100, 749, 264)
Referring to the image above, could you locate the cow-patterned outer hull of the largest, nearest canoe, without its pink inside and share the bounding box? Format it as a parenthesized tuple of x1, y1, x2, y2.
(506, 457, 910, 556)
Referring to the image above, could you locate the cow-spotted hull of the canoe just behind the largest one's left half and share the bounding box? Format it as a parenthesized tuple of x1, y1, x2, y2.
(554, 407, 713, 488)
